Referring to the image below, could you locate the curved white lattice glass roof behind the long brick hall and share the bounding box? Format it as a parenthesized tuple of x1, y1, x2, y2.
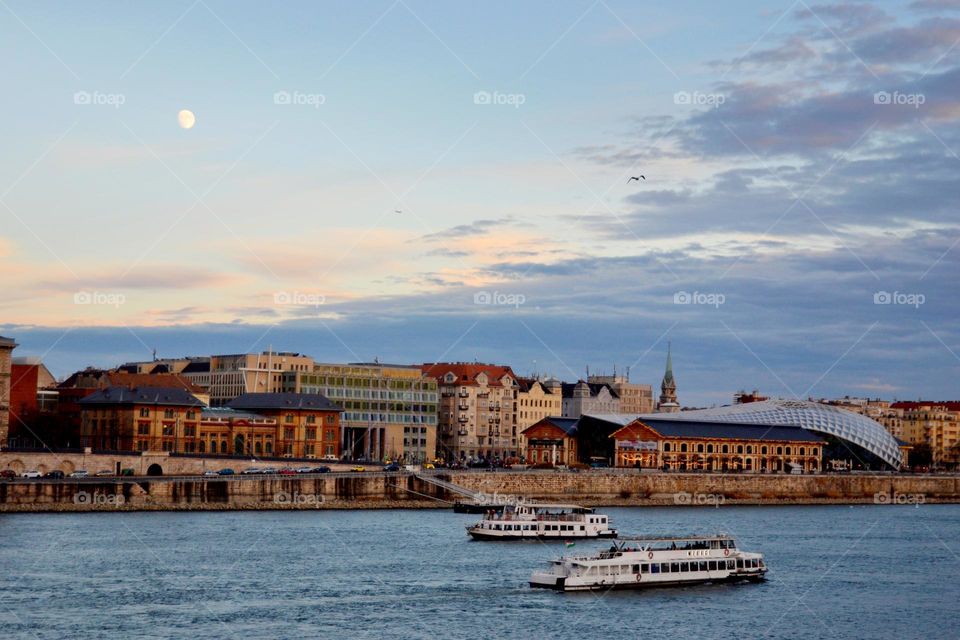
(648, 400, 903, 469)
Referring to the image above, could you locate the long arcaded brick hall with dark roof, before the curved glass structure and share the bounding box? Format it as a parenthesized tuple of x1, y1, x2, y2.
(610, 417, 825, 473)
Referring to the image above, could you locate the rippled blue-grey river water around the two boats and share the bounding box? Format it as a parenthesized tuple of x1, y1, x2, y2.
(0, 505, 960, 640)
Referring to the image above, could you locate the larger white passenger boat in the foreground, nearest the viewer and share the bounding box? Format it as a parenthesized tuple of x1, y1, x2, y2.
(530, 535, 767, 591)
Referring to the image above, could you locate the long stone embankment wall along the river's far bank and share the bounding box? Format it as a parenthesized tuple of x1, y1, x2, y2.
(0, 471, 960, 512)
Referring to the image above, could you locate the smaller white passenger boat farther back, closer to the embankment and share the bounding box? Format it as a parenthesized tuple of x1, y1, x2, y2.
(467, 502, 617, 541)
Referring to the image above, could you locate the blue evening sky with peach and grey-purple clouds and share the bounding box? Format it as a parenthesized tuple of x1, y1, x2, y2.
(0, 0, 960, 406)
